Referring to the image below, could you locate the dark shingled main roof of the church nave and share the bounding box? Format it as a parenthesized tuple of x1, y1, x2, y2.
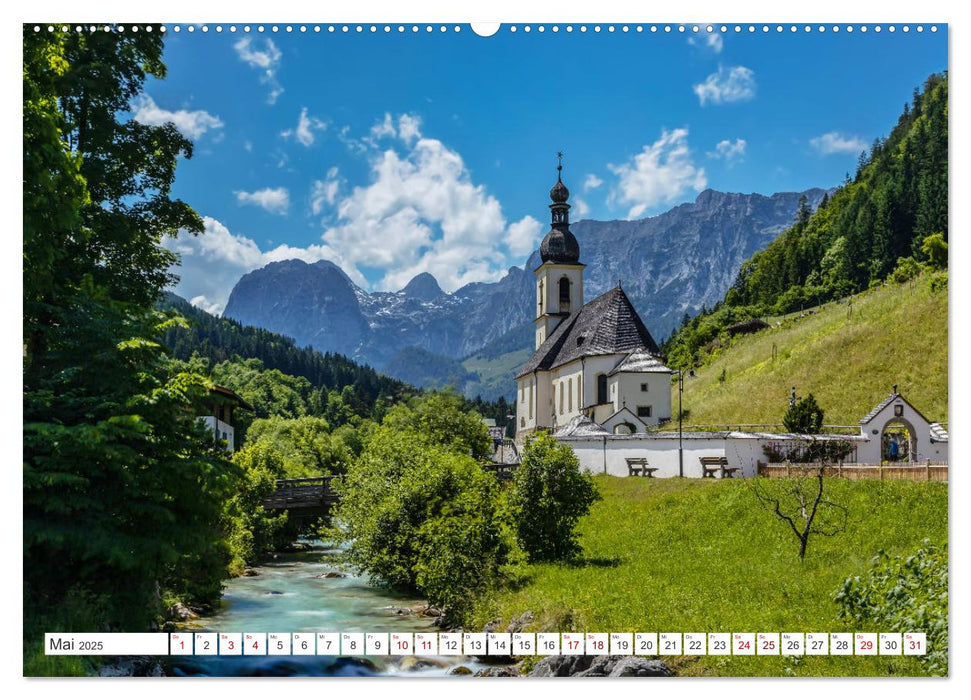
(517, 286, 659, 377)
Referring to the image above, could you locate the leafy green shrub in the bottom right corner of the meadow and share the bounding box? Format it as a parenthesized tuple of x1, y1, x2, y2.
(834, 540, 948, 676)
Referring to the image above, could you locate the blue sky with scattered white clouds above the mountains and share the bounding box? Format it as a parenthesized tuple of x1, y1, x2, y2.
(146, 25, 947, 312)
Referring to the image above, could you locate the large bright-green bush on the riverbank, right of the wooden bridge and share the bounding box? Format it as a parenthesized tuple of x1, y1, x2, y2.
(334, 426, 506, 617)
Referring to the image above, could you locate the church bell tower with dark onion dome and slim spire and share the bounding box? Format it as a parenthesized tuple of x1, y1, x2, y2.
(536, 152, 584, 348)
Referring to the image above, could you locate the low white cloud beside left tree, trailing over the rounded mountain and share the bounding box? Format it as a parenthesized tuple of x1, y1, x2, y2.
(164, 216, 346, 314)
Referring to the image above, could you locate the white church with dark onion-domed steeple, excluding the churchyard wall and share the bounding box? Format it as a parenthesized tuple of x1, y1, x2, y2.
(516, 164, 672, 443)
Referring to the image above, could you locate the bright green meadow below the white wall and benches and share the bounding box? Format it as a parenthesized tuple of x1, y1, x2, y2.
(474, 476, 947, 676)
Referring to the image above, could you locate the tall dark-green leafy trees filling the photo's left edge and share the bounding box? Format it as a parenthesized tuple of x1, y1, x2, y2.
(23, 26, 238, 654)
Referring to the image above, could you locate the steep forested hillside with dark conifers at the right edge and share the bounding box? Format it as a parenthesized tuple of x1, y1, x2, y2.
(664, 72, 948, 366)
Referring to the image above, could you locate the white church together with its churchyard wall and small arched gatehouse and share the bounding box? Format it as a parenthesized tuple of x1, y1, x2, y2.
(516, 164, 949, 480)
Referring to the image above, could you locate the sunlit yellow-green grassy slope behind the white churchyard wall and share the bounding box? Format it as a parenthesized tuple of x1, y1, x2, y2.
(672, 275, 947, 425)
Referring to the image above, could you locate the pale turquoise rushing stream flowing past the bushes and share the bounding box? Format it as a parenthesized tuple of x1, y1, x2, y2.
(166, 541, 482, 676)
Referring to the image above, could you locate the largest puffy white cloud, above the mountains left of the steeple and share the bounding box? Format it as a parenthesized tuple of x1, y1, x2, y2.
(323, 114, 535, 291)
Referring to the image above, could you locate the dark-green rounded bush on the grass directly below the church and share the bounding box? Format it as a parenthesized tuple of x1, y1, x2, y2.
(510, 433, 600, 561)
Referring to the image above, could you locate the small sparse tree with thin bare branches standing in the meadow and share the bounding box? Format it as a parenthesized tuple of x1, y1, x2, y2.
(750, 464, 847, 561)
